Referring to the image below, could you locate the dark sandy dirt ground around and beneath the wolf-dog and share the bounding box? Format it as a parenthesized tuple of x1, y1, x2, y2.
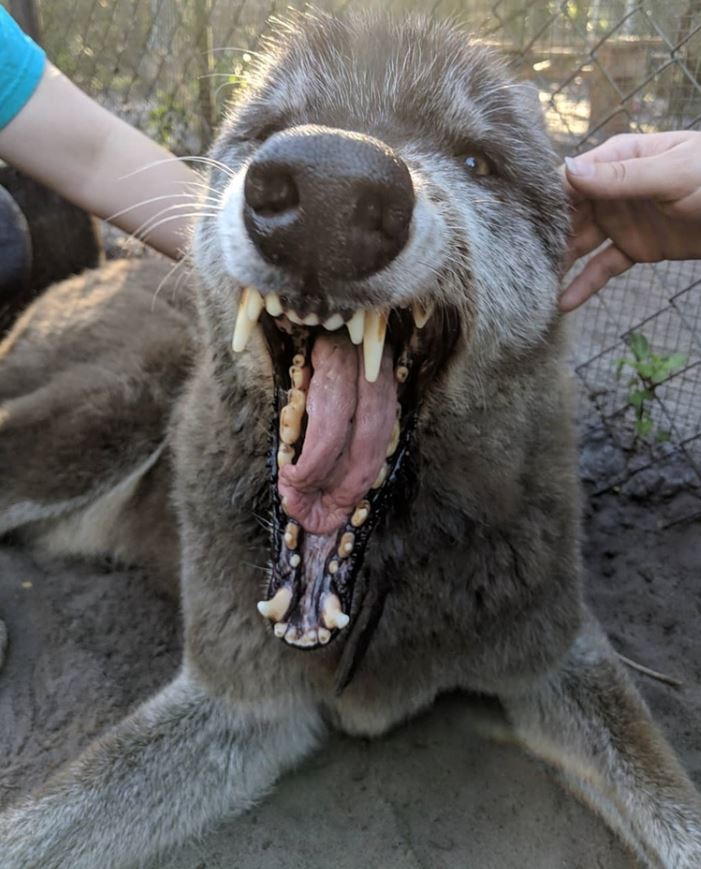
(0, 434, 701, 869)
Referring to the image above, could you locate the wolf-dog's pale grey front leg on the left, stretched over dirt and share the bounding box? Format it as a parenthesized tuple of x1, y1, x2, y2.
(0, 672, 321, 869)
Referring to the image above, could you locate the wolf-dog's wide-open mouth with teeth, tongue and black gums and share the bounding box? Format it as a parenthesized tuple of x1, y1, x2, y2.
(233, 288, 459, 649)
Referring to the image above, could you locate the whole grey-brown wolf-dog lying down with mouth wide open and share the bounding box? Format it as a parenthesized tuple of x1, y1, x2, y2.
(0, 15, 701, 869)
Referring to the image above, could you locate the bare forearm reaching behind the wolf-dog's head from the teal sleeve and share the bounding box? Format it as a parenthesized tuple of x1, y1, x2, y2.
(0, 63, 201, 258)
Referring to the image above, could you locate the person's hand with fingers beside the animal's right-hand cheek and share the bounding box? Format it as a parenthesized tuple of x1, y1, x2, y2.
(560, 131, 701, 311)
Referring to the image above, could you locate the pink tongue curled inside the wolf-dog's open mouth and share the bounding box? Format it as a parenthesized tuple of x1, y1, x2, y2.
(278, 334, 397, 534)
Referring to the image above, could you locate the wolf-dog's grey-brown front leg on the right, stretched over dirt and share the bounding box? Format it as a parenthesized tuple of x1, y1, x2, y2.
(500, 618, 701, 869)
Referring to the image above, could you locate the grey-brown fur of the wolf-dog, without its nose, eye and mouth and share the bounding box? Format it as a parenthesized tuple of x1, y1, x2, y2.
(0, 18, 701, 869)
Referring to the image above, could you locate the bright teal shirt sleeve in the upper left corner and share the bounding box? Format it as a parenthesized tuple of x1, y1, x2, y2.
(0, 6, 46, 130)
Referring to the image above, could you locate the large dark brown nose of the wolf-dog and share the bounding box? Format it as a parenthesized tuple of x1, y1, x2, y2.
(243, 127, 414, 280)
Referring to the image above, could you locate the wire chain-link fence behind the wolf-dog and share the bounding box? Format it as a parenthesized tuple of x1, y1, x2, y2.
(9, 0, 701, 519)
